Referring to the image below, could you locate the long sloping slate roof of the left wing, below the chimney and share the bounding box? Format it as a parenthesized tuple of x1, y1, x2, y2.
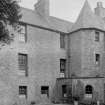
(20, 7, 73, 33)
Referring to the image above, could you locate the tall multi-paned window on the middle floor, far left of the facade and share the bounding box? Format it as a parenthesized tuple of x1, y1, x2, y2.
(18, 53, 28, 76)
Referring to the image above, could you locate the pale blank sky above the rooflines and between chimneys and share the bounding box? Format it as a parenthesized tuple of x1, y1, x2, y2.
(20, 0, 105, 22)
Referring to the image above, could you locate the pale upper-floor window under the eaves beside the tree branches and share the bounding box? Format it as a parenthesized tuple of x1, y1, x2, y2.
(18, 24, 26, 42)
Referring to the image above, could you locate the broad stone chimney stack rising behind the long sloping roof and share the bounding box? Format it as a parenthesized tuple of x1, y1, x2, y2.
(35, 0, 49, 17)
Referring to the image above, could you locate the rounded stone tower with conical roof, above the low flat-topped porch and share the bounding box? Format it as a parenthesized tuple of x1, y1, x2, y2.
(69, 0, 104, 77)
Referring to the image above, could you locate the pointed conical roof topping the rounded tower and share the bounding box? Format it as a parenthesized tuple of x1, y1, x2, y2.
(71, 0, 105, 32)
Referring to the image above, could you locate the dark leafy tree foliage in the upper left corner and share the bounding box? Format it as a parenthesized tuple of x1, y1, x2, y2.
(0, 0, 22, 44)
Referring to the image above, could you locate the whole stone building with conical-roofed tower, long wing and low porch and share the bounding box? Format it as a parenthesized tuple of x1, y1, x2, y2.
(0, 0, 105, 104)
